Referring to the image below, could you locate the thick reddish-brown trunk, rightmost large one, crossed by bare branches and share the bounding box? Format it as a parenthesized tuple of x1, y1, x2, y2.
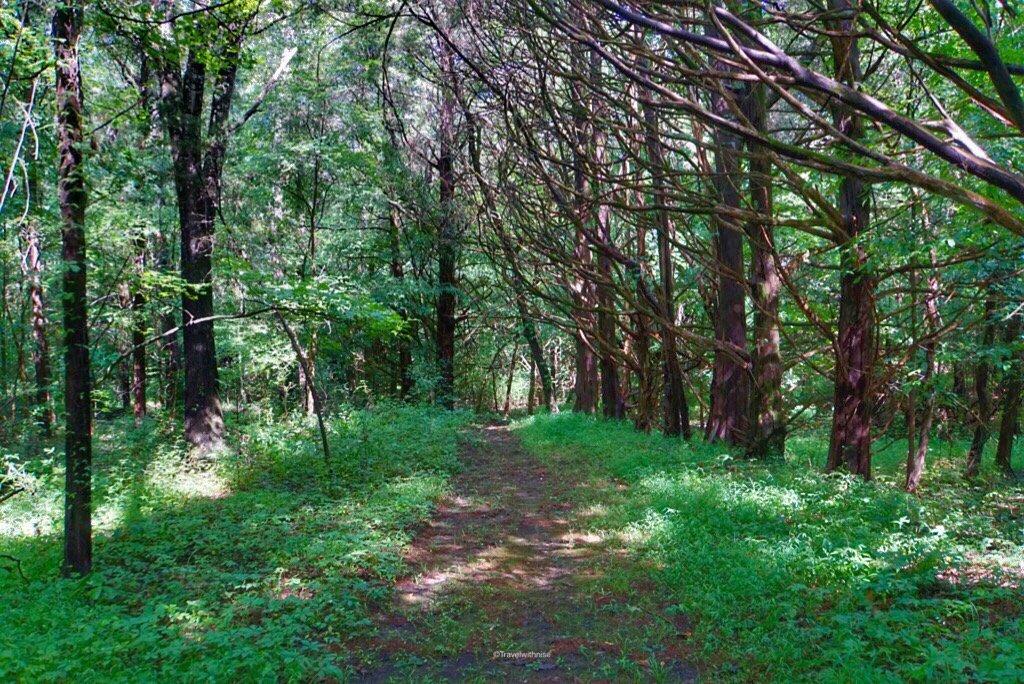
(826, 0, 874, 479)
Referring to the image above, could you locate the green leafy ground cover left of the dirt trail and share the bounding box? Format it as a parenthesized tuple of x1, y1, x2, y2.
(0, 407, 469, 681)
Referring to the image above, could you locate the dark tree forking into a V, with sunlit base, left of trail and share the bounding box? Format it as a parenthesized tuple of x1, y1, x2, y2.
(154, 7, 272, 452)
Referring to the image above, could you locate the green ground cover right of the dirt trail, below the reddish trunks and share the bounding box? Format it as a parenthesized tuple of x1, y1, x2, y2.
(517, 415, 1024, 682)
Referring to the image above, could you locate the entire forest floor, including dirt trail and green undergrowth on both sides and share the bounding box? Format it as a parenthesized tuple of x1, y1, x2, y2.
(0, 405, 1024, 683)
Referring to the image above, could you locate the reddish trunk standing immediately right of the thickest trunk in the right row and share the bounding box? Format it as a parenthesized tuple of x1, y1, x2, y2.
(746, 83, 785, 459)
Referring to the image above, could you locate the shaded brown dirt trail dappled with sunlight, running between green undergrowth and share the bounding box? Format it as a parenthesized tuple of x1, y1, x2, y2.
(359, 426, 696, 682)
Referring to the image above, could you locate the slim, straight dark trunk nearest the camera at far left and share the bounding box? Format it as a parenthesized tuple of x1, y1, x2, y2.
(53, 0, 92, 574)
